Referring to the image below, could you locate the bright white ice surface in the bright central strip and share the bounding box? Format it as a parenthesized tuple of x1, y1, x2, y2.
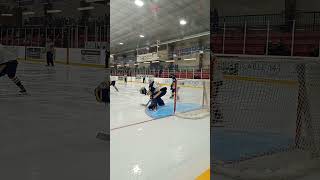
(110, 81, 210, 180)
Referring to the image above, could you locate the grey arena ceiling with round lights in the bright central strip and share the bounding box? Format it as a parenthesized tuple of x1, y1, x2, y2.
(110, 0, 210, 53)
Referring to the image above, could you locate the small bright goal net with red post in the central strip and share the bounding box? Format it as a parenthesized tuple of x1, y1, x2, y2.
(174, 79, 210, 120)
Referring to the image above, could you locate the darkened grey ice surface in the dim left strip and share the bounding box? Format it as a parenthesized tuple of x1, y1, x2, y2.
(0, 62, 109, 180)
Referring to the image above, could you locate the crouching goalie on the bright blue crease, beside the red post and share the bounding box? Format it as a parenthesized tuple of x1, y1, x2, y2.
(140, 81, 167, 111)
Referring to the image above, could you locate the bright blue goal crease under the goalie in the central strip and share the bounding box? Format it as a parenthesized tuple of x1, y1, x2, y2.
(145, 102, 201, 119)
